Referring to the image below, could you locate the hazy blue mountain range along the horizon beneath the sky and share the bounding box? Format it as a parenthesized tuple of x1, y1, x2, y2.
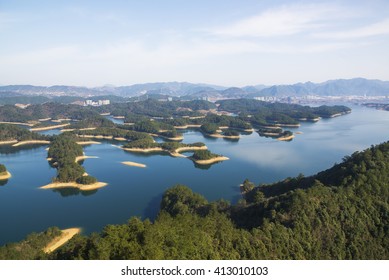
(0, 78, 389, 99)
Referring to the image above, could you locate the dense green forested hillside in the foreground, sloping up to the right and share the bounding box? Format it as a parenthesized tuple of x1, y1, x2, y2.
(0, 142, 389, 259)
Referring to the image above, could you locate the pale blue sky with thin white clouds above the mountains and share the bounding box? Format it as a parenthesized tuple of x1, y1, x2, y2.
(0, 0, 389, 87)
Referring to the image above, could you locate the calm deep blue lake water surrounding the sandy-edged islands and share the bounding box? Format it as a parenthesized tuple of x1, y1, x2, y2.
(0, 107, 389, 244)
